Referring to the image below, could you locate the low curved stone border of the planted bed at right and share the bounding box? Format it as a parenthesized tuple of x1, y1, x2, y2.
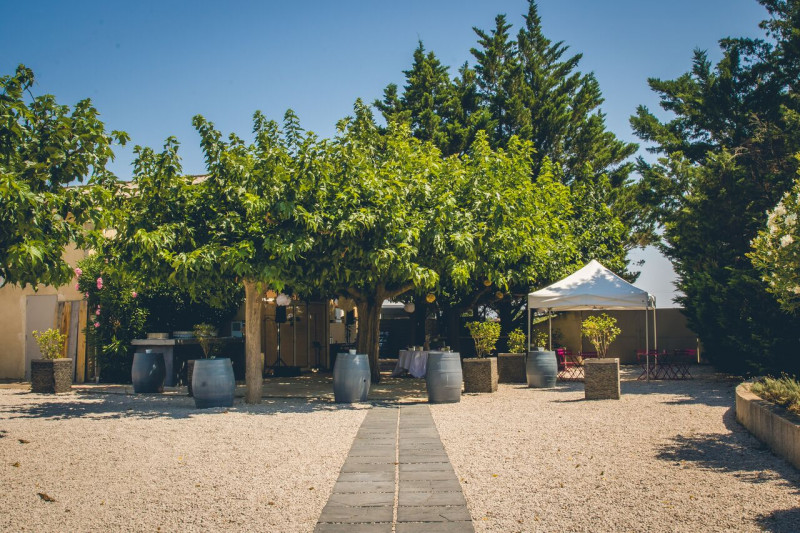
(736, 382, 800, 469)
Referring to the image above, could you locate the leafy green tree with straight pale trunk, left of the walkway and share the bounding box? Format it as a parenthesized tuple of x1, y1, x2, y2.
(107, 112, 306, 403)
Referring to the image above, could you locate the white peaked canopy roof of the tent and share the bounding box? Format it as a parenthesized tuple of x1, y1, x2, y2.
(528, 259, 655, 311)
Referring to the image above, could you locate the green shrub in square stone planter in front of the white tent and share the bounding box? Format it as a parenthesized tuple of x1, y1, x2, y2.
(581, 313, 621, 400)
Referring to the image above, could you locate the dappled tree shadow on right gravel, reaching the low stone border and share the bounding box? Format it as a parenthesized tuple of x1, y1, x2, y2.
(656, 426, 800, 492)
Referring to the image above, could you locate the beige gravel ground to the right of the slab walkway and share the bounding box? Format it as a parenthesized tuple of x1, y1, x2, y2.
(431, 376, 800, 532)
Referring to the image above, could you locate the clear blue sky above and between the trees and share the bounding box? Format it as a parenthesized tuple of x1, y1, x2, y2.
(0, 0, 766, 305)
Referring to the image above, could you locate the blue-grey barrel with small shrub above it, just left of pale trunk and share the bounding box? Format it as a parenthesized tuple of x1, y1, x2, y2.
(189, 324, 236, 409)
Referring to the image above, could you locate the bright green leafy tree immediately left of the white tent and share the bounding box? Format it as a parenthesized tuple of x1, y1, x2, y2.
(423, 133, 575, 350)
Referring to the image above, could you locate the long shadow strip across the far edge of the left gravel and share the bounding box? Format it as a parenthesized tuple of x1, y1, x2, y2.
(0, 393, 368, 420)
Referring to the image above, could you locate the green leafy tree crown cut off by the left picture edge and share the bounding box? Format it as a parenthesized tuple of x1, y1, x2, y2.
(0, 65, 128, 287)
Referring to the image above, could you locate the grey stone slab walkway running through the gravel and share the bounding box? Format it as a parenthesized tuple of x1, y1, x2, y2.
(315, 405, 474, 533)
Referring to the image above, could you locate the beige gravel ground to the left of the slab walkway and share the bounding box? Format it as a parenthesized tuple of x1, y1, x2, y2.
(0, 389, 366, 531)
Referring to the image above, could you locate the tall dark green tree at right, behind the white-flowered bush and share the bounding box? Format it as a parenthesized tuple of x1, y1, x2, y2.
(631, 0, 800, 373)
